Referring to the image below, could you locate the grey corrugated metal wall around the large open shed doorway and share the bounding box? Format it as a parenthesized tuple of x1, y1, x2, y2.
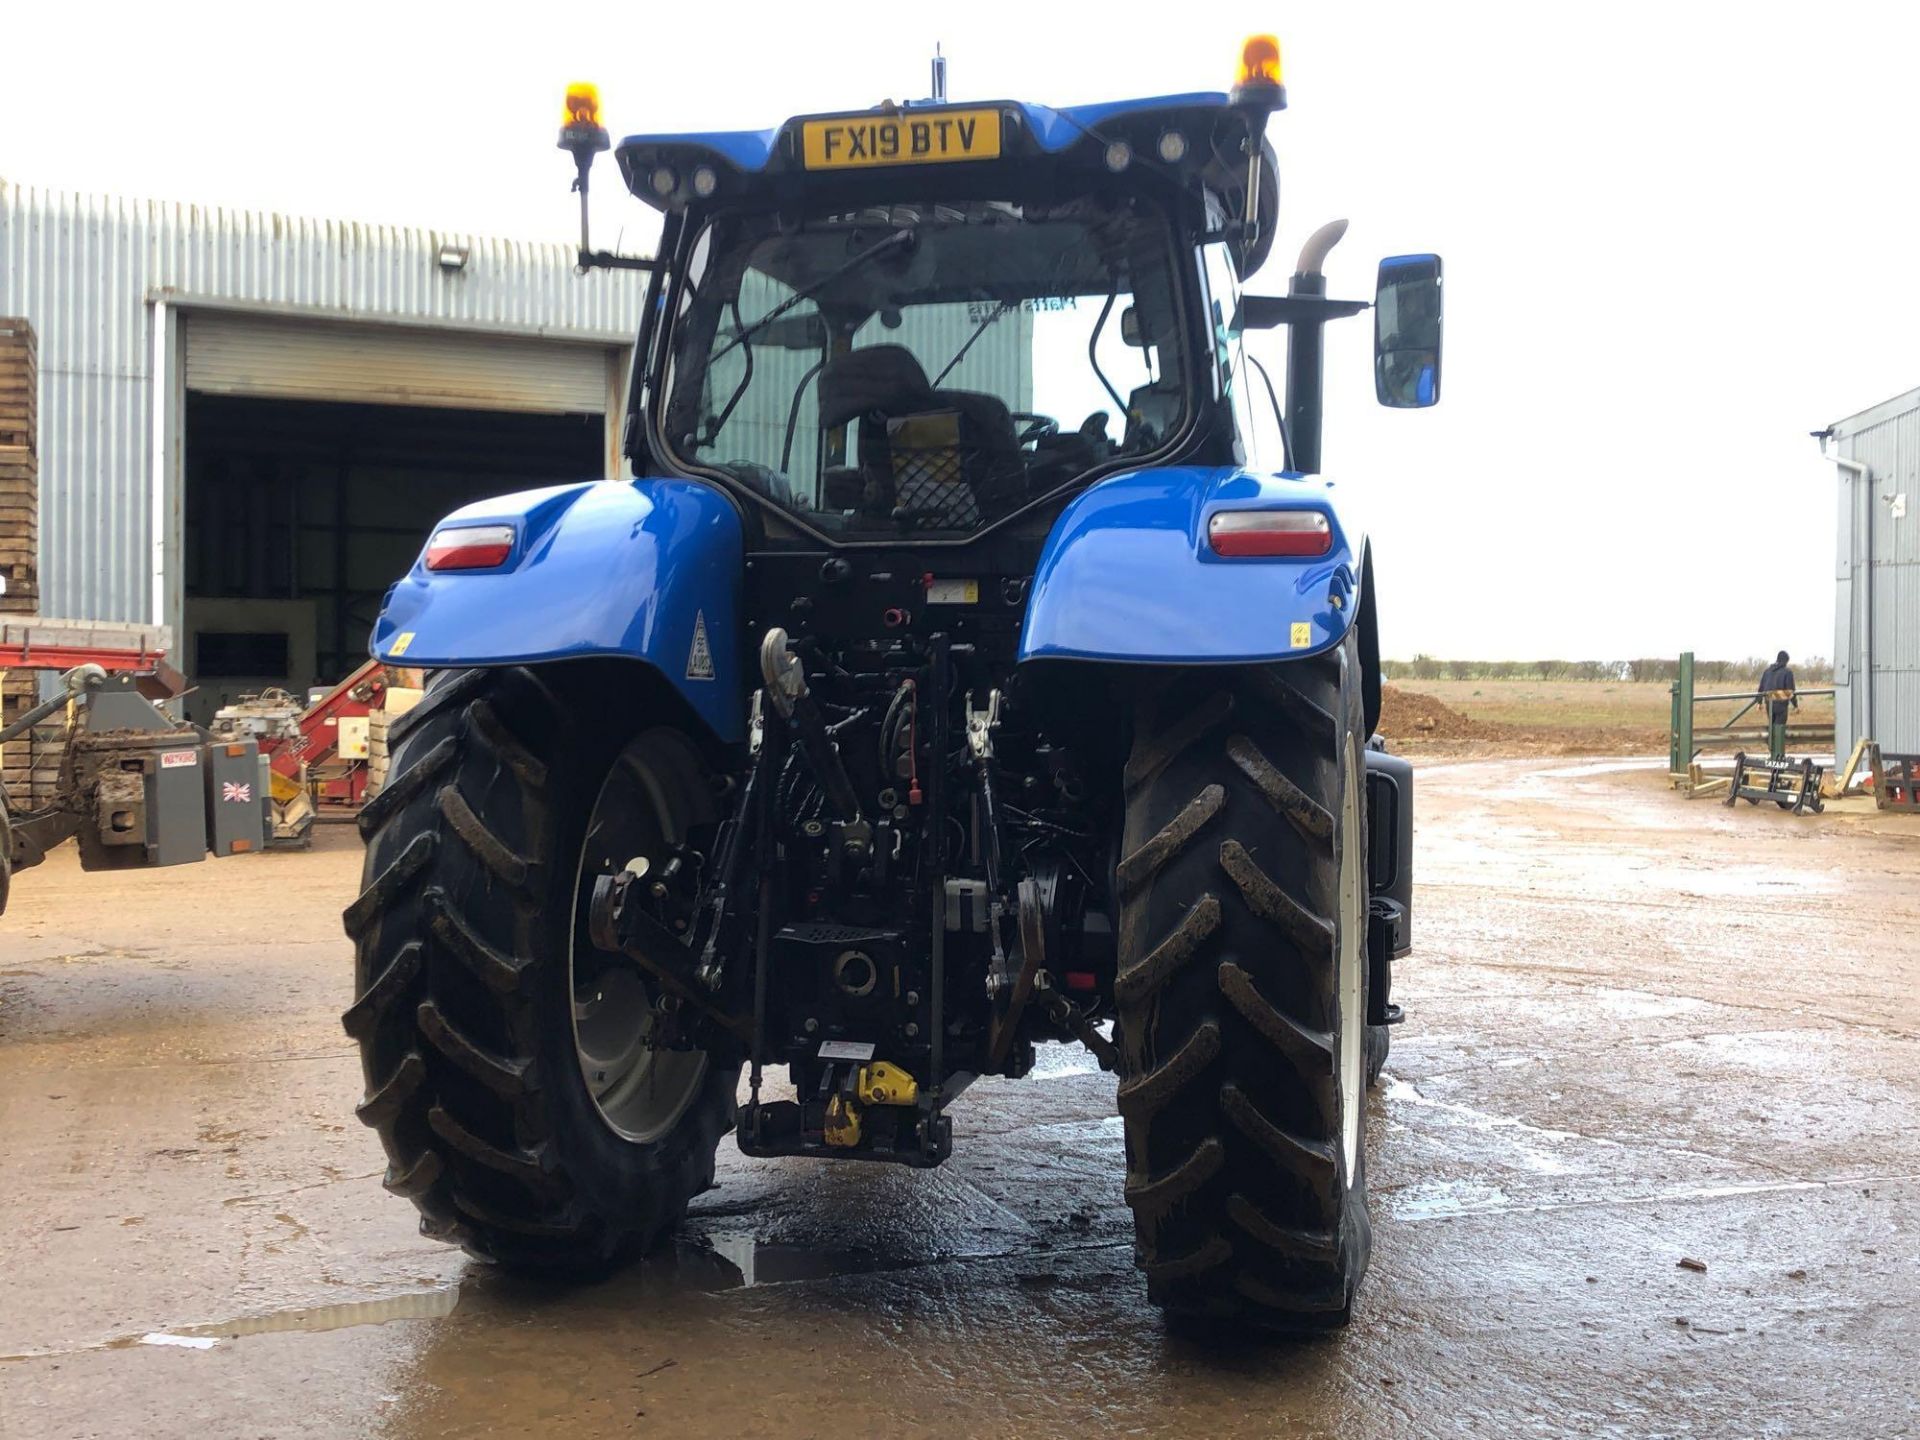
(0, 180, 647, 620)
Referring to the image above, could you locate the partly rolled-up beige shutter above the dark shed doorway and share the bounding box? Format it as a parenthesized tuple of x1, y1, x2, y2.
(186, 313, 607, 415)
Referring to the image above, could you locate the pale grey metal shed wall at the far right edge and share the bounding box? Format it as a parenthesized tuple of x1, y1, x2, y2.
(1834, 390, 1920, 755)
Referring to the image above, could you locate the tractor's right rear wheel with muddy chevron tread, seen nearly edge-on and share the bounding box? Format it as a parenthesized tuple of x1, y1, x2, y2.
(1116, 634, 1384, 1329)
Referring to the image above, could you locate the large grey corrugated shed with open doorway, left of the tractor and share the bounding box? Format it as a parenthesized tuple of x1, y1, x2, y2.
(0, 180, 647, 708)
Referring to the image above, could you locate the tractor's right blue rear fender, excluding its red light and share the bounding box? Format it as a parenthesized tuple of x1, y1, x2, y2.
(1020, 467, 1365, 664)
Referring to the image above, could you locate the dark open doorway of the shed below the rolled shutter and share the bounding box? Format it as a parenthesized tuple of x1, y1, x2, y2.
(180, 394, 607, 724)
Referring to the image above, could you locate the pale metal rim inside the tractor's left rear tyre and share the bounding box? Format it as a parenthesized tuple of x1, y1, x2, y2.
(566, 737, 707, 1144)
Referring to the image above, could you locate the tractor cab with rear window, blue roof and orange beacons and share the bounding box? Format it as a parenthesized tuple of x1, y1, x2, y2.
(561, 40, 1438, 547)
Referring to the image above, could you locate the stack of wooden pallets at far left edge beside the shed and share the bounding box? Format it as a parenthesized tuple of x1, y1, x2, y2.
(0, 317, 40, 804)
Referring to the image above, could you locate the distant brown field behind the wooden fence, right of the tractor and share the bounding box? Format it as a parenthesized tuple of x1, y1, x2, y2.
(1380, 680, 1834, 755)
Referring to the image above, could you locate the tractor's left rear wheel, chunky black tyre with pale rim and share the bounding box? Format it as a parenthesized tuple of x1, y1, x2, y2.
(342, 668, 739, 1273)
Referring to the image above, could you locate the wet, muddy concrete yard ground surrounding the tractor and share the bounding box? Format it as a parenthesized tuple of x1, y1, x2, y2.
(0, 760, 1920, 1440)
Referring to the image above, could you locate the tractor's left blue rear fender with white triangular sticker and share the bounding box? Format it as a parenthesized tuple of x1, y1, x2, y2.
(372, 480, 745, 741)
